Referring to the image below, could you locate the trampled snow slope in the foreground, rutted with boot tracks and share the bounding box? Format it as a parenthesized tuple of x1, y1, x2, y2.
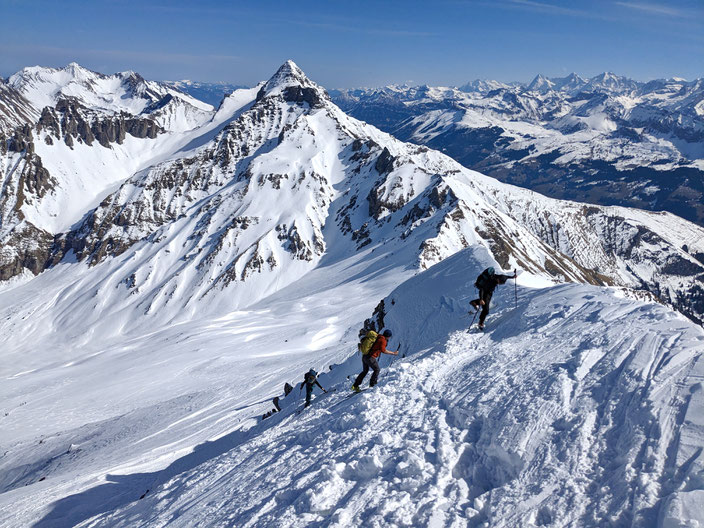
(24, 256, 704, 527)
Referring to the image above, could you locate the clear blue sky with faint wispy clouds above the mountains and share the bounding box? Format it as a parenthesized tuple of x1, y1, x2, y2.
(0, 0, 704, 88)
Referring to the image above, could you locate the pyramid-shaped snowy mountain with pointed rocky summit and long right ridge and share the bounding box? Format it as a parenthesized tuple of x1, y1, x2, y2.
(5, 63, 704, 326)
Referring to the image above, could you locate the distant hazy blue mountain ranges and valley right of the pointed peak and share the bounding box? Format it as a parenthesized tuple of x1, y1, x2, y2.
(333, 73, 704, 225)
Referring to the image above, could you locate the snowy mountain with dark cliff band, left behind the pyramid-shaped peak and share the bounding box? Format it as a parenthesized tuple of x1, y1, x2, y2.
(0, 64, 260, 279)
